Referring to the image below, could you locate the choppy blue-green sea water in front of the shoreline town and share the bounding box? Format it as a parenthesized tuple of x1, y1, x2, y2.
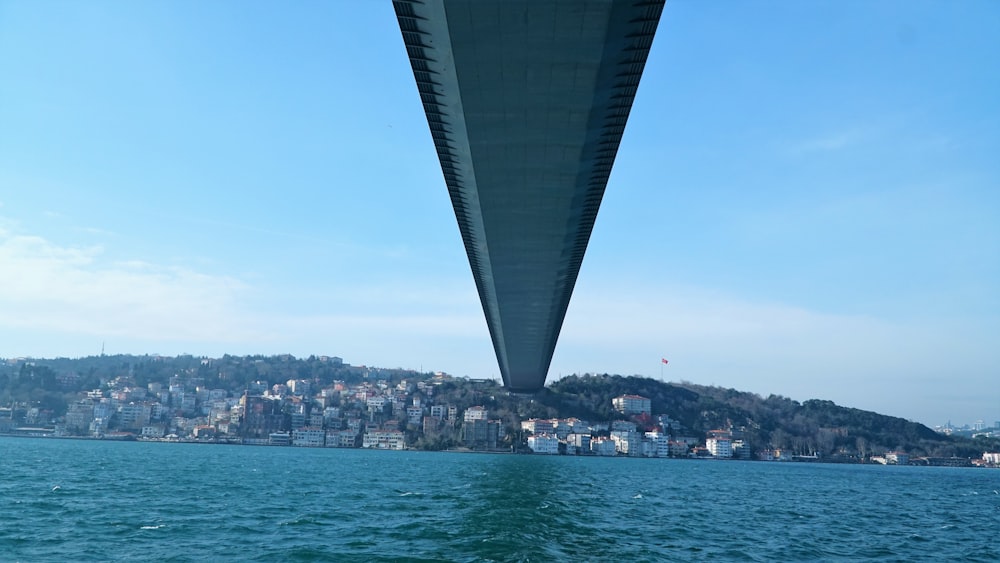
(0, 438, 1000, 563)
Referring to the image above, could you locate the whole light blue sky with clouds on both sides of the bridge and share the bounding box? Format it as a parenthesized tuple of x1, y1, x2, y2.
(0, 0, 1000, 425)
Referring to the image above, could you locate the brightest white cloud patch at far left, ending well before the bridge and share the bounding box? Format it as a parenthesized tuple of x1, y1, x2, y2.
(0, 232, 259, 341)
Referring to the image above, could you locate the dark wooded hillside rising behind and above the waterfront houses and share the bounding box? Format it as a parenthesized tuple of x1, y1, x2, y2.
(0, 355, 1000, 461)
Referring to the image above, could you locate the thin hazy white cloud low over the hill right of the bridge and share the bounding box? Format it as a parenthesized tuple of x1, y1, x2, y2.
(550, 287, 1000, 422)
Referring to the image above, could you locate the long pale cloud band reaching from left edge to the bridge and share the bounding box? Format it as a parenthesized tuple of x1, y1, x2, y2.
(0, 225, 495, 374)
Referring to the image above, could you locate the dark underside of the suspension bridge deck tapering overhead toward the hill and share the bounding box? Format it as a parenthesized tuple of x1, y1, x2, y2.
(393, 0, 664, 392)
